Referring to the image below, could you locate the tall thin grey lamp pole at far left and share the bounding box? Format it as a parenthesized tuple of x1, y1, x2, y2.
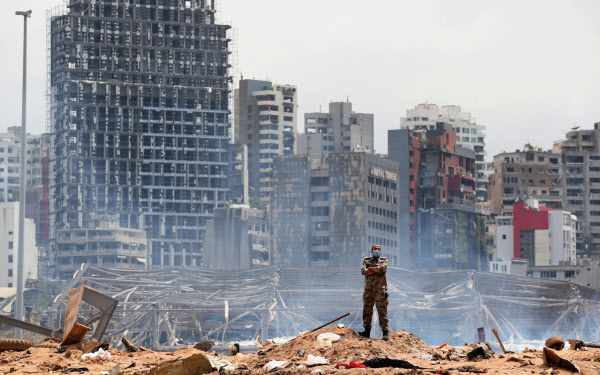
(15, 10, 31, 339)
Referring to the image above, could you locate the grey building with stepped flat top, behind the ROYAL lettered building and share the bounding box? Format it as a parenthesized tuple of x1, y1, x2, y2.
(297, 102, 375, 158)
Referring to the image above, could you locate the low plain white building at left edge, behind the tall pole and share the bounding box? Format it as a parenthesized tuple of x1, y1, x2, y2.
(0, 202, 38, 288)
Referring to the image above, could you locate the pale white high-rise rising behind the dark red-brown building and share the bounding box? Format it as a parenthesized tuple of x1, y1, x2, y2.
(400, 103, 488, 202)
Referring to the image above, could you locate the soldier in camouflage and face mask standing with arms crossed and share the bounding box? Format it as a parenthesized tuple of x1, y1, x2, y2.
(359, 244, 390, 341)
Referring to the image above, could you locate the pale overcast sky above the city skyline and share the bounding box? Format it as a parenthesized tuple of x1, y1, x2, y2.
(0, 0, 600, 160)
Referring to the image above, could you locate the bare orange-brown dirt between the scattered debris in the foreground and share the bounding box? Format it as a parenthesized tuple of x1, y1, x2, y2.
(0, 327, 600, 375)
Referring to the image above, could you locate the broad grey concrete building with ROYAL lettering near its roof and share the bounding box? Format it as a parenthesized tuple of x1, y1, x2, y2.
(271, 152, 401, 267)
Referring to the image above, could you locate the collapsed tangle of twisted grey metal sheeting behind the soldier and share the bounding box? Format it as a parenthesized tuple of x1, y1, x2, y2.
(15, 266, 600, 350)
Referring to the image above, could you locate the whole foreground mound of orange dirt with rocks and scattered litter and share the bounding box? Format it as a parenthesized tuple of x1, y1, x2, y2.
(0, 327, 600, 375)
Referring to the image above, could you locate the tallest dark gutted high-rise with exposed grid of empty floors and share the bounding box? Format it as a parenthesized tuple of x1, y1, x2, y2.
(50, 0, 230, 267)
